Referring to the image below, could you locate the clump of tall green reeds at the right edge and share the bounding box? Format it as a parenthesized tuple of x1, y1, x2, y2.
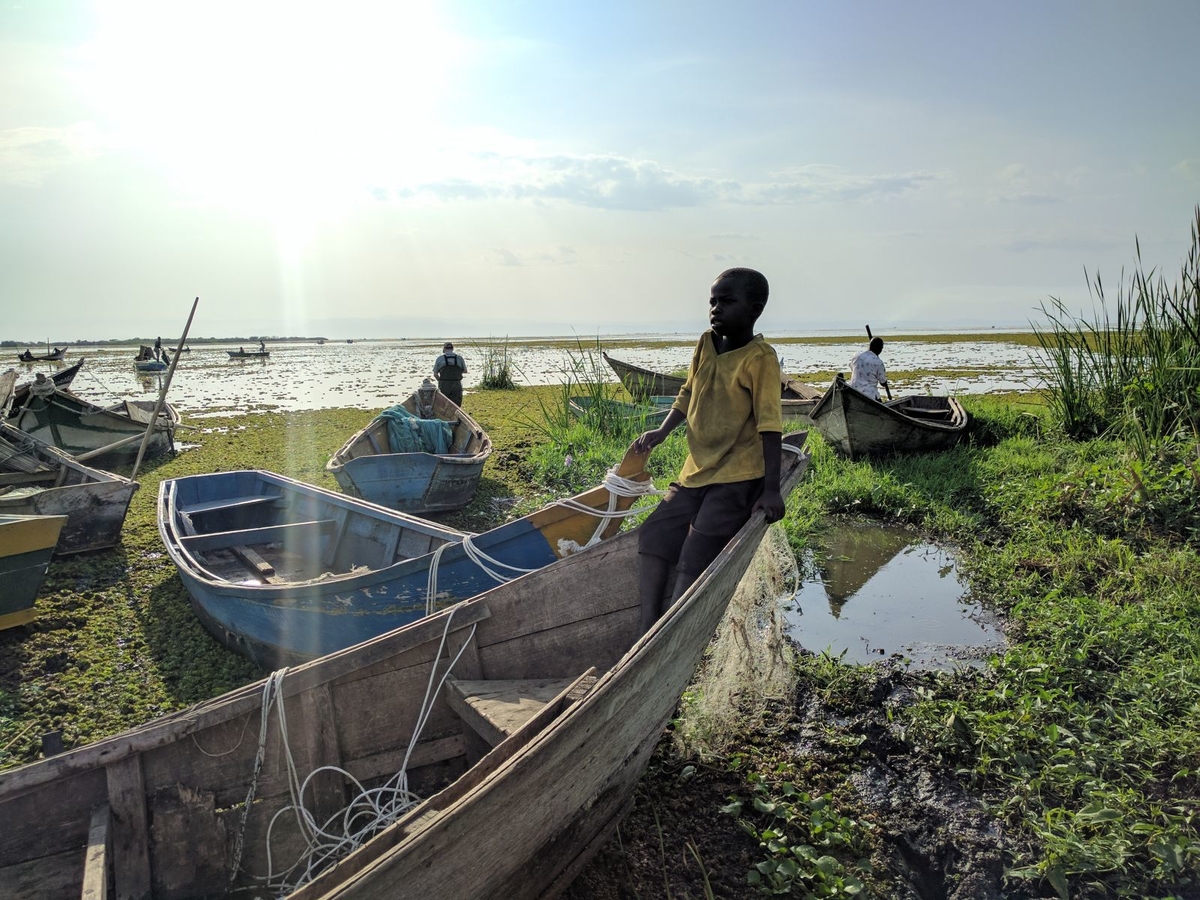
(1033, 205, 1200, 445)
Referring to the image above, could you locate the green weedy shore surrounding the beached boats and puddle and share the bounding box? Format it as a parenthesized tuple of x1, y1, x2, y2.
(0, 388, 1200, 900)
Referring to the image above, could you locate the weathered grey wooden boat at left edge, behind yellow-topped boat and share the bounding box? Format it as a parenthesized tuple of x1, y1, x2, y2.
(0, 424, 138, 556)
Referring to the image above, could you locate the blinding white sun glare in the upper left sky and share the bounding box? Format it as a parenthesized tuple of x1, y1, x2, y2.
(82, 0, 464, 221)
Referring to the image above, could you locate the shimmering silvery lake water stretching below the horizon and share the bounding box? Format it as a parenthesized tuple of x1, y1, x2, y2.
(13, 335, 1036, 415)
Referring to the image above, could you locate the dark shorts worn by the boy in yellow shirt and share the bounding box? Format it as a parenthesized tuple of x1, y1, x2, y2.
(637, 478, 763, 563)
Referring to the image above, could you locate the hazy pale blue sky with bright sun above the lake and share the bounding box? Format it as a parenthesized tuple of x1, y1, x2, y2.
(0, 0, 1200, 341)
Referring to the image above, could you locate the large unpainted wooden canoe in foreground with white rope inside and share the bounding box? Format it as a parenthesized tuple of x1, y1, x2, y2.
(0, 434, 808, 900)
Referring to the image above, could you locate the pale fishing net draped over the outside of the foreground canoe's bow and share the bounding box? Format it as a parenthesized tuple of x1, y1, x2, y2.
(673, 526, 799, 758)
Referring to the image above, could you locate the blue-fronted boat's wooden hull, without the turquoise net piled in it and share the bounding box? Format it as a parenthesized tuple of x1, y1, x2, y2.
(325, 391, 492, 512)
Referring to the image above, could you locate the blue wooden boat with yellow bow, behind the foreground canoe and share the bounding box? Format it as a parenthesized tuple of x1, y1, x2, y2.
(158, 454, 649, 667)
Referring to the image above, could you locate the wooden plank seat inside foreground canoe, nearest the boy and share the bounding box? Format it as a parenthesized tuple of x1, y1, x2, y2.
(444, 668, 596, 746)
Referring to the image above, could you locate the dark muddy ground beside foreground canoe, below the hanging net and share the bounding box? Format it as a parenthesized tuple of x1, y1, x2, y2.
(563, 668, 1012, 900)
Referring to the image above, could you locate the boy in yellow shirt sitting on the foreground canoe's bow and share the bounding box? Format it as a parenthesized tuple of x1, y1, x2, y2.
(631, 269, 784, 632)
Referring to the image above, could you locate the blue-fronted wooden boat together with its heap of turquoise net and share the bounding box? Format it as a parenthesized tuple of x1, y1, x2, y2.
(325, 379, 492, 512)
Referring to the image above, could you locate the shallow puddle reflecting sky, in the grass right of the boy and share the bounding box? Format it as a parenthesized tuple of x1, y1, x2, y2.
(785, 524, 1003, 668)
